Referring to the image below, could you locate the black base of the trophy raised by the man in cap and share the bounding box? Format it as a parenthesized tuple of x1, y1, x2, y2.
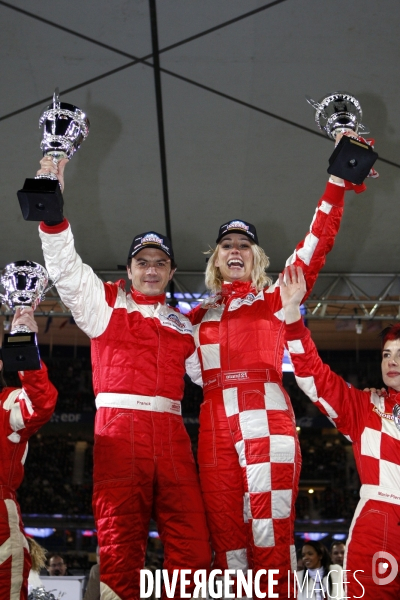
(17, 179, 64, 223)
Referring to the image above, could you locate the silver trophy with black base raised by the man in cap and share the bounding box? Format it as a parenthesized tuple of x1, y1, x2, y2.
(17, 88, 90, 222)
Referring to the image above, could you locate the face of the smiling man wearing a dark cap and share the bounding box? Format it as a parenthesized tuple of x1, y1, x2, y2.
(127, 248, 175, 296)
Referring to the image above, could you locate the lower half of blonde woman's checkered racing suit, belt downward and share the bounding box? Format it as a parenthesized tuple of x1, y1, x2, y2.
(198, 369, 301, 598)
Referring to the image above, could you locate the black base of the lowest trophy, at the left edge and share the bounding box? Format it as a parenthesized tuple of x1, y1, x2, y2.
(1, 332, 40, 371)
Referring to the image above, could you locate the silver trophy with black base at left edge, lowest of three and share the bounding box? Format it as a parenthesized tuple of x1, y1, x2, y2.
(0, 260, 54, 371)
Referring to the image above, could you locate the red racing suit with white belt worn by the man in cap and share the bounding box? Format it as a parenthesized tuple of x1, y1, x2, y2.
(40, 221, 211, 600)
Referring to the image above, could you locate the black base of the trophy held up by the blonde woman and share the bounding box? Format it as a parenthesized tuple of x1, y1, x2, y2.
(328, 135, 378, 185)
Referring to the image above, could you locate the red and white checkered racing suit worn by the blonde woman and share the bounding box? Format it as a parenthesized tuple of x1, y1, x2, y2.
(188, 183, 344, 598)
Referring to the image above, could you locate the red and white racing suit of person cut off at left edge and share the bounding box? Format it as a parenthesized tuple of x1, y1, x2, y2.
(0, 363, 57, 600)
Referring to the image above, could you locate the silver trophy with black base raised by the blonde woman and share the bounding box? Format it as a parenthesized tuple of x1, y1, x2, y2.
(306, 92, 378, 185)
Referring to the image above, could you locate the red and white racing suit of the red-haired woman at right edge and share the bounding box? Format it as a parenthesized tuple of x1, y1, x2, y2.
(286, 320, 400, 600)
